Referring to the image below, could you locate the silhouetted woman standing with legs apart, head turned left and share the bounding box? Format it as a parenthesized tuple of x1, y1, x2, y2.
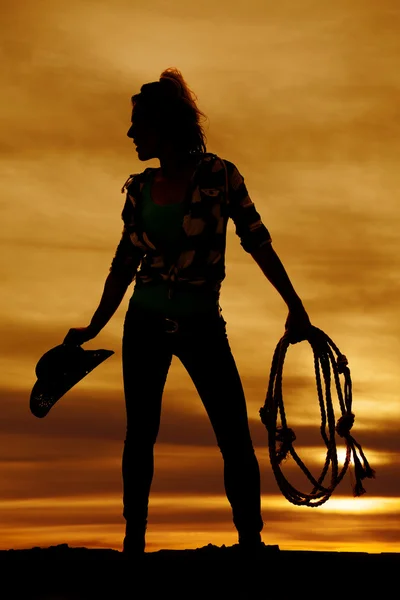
(64, 68, 311, 556)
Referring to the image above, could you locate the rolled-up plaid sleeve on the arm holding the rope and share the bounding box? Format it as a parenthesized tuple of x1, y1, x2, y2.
(224, 161, 272, 253)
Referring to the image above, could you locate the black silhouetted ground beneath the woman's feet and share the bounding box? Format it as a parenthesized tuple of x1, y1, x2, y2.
(0, 544, 400, 600)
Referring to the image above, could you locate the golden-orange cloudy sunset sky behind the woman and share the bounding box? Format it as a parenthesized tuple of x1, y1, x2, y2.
(0, 0, 400, 552)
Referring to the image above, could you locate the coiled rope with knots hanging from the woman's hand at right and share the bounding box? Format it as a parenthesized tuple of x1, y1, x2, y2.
(260, 326, 375, 507)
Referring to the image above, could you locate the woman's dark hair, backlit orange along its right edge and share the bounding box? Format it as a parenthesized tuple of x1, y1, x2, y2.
(131, 67, 207, 152)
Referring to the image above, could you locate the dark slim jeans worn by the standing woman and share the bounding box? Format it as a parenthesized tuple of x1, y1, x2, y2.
(122, 306, 263, 534)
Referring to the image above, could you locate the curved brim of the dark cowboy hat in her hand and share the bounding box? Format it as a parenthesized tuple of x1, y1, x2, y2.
(29, 350, 114, 419)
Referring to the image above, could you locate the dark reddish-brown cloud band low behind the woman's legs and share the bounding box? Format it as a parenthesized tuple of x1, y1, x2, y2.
(0, 378, 399, 504)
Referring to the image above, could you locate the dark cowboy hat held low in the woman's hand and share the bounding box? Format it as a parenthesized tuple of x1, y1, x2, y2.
(30, 344, 114, 418)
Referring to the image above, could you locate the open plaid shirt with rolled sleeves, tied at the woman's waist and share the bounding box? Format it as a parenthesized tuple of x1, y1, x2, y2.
(110, 152, 271, 293)
